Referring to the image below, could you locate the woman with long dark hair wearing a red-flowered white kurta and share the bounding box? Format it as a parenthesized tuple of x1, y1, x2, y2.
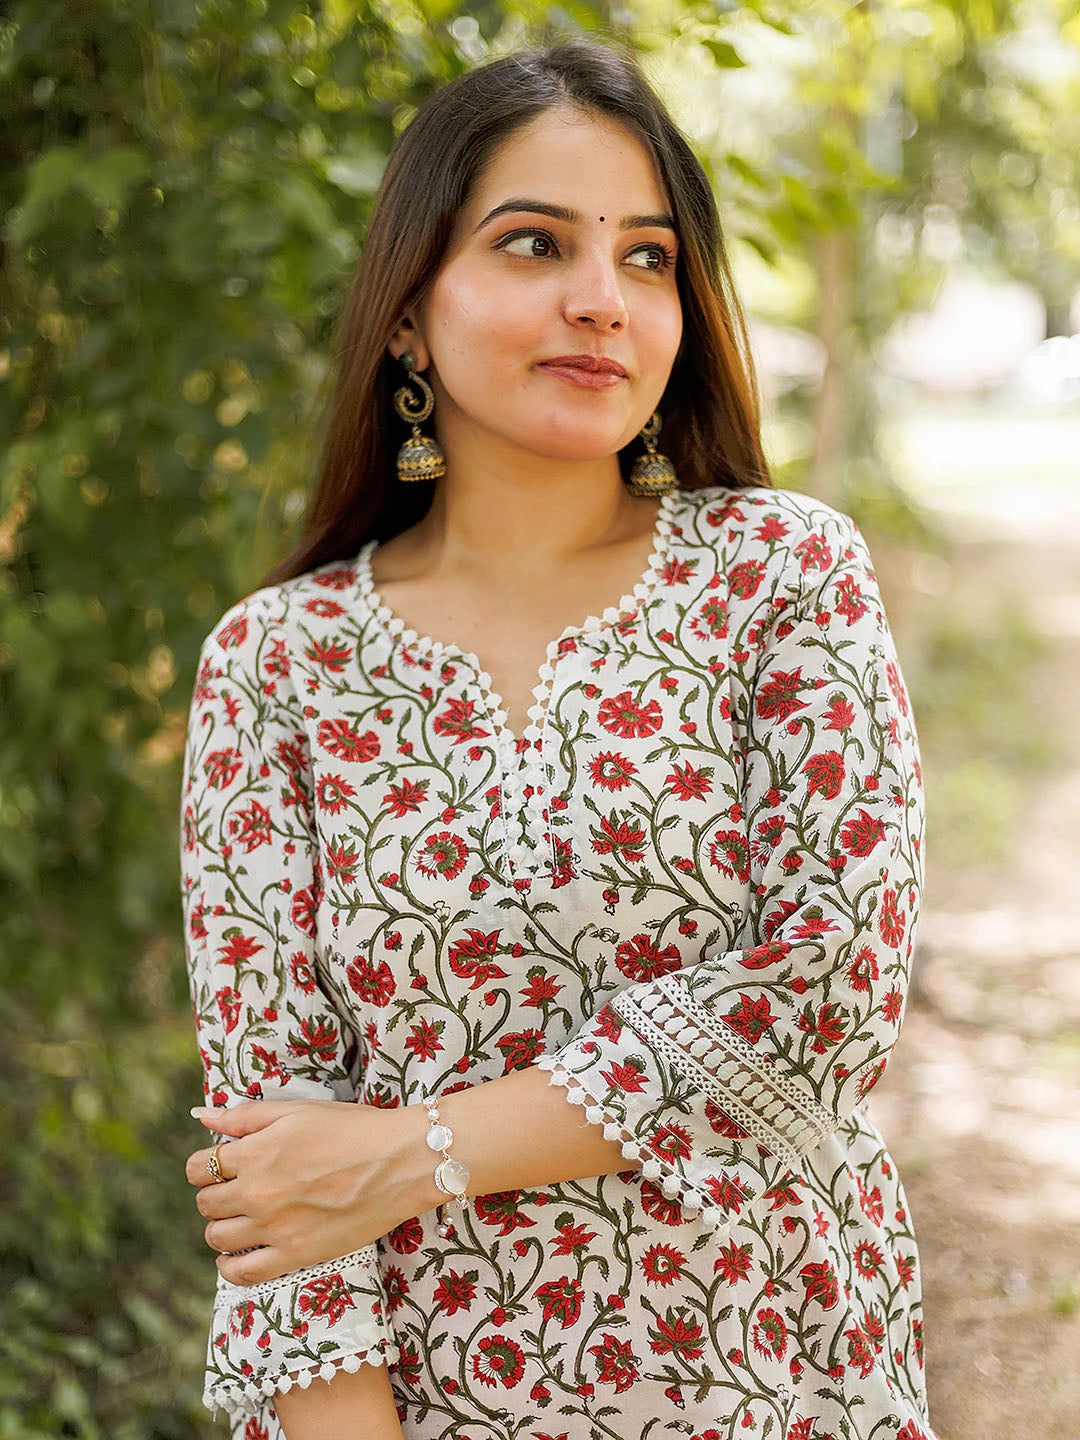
(183, 40, 932, 1440)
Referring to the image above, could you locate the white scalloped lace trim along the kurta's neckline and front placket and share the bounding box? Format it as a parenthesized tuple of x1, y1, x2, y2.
(356, 491, 680, 884)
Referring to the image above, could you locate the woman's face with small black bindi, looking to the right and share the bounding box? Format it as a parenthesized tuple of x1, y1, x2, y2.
(392, 108, 683, 459)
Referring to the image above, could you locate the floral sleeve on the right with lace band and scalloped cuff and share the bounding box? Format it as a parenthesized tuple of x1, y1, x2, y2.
(537, 507, 923, 1228)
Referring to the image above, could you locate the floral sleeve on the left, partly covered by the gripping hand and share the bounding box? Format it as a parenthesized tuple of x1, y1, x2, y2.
(180, 589, 392, 1420)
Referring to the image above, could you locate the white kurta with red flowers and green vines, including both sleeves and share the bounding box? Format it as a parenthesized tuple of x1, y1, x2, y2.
(183, 487, 933, 1440)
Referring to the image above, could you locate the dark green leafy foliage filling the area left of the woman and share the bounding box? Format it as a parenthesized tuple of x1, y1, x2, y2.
(0, 0, 610, 1422)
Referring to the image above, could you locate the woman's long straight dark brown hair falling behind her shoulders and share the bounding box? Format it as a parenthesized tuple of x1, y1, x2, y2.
(264, 28, 772, 585)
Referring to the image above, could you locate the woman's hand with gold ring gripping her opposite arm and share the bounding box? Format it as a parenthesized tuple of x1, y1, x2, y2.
(184, 1100, 432, 1284)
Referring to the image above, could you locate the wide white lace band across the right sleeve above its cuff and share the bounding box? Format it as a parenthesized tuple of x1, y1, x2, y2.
(622, 971, 840, 1166)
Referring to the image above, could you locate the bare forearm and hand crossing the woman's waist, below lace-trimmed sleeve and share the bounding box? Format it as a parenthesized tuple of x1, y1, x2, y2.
(187, 1068, 624, 1286)
